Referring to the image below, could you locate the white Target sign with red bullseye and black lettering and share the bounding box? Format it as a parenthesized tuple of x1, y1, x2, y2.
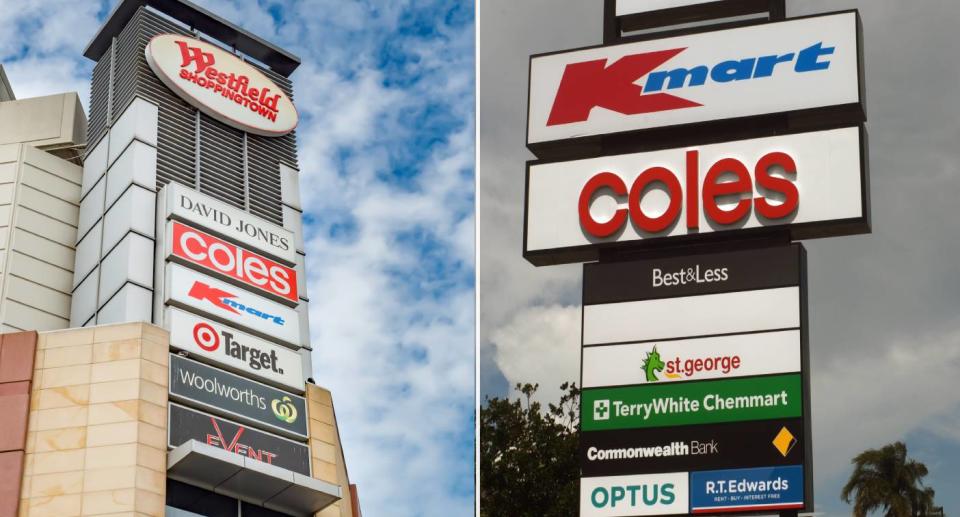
(164, 307, 304, 393)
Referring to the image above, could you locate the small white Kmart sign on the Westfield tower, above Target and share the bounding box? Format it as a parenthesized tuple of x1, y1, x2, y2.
(164, 263, 301, 347)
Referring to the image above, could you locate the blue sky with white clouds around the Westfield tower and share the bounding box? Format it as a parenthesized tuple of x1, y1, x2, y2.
(0, 0, 474, 516)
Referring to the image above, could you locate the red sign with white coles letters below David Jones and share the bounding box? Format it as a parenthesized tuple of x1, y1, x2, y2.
(173, 221, 299, 303)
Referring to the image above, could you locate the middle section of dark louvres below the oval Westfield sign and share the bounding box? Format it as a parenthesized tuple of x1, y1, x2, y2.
(200, 116, 246, 210)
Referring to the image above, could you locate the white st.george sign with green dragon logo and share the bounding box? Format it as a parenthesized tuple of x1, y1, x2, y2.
(581, 329, 800, 388)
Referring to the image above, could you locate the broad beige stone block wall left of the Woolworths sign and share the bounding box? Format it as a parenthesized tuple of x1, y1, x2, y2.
(20, 323, 169, 516)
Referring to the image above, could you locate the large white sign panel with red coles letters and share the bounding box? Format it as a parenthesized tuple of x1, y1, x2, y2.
(524, 127, 870, 262)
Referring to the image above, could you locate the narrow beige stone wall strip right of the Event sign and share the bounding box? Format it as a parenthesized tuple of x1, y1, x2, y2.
(307, 384, 359, 517)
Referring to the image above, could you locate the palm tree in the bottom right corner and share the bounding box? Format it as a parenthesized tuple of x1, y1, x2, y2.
(840, 442, 940, 517)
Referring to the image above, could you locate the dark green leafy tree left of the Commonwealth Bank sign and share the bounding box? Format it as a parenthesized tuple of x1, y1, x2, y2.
(480, 383, 580, 517)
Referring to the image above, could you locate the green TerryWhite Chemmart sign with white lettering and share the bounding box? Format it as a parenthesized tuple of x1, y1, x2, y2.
(580, 374, 803, 431)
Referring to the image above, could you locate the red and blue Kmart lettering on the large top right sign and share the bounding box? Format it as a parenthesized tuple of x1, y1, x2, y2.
(547, 42, 834, 126)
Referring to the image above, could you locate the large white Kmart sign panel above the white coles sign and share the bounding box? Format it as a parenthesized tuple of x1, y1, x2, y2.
(527, 12, 862, 145)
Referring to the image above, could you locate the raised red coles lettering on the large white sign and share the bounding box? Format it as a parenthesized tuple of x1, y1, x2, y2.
(578, 150, 800, 238)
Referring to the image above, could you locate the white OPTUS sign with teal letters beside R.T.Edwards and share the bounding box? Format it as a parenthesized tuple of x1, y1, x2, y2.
(580, 472, 689, 517)
